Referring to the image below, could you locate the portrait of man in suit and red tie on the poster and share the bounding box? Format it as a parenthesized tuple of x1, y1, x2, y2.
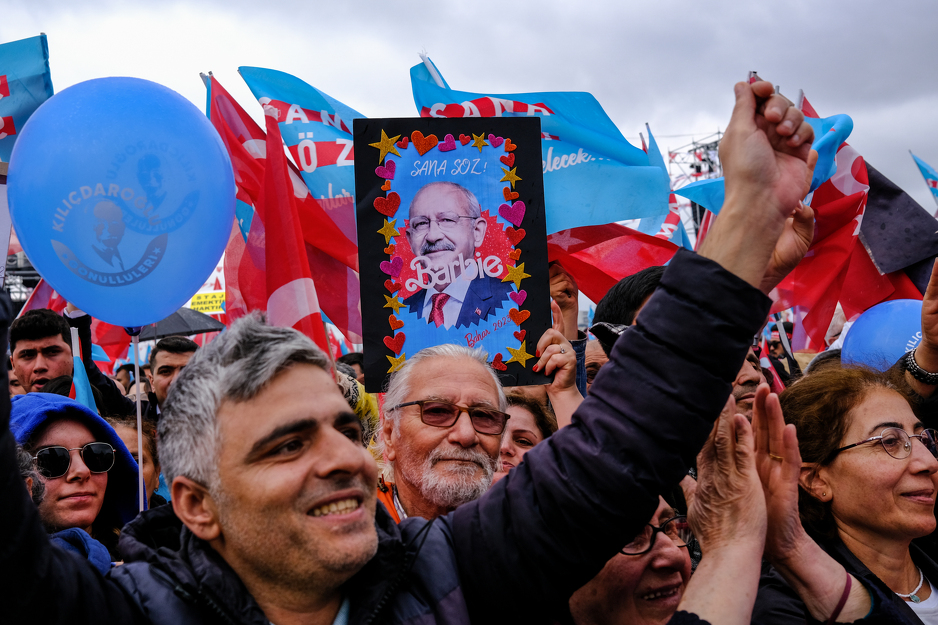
(404, 181, 511, 329)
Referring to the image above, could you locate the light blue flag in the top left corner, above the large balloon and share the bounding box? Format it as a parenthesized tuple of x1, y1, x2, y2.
(0, 35, 53, 161)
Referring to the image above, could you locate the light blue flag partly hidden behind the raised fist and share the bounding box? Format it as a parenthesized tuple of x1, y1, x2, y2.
(674, 115, 853, 214)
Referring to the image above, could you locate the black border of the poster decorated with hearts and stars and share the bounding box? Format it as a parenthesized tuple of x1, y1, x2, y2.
(353, 117, 551, 393)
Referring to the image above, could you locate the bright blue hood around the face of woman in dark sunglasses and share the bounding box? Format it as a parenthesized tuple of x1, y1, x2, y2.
(10, 393, 139, 560)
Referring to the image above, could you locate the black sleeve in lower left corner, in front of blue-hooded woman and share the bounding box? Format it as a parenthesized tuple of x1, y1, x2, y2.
(0, 293, 144, 625)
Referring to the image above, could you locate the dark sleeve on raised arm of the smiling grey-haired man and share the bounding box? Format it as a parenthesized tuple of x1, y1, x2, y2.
(451, 252, 771, 623)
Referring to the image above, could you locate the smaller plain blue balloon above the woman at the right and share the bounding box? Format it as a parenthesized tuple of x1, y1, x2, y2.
(840, 299, 922, 371)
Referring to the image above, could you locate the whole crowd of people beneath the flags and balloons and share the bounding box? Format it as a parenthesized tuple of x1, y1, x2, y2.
(0, 82, 938, 625)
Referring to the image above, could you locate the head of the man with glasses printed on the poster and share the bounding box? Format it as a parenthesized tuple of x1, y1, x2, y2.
(406, 185, 486, 291)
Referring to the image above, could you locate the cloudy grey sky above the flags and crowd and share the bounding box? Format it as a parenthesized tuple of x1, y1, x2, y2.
(0, 0, 938, 210)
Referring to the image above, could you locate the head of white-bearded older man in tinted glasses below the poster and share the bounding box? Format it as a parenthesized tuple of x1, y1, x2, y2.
(378, 345, 508, 522)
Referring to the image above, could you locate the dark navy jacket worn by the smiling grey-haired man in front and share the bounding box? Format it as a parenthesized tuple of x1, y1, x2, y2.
(0, 252, 770, 625)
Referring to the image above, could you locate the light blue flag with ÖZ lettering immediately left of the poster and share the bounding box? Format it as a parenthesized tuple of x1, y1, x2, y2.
(238, 67, 365, 241)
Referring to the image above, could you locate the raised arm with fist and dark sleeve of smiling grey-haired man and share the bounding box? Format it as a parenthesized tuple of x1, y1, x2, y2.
(444, 83, 812, 622)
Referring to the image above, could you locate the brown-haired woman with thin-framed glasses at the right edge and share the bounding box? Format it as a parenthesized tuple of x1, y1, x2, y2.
(753, 369, 938, 623)
